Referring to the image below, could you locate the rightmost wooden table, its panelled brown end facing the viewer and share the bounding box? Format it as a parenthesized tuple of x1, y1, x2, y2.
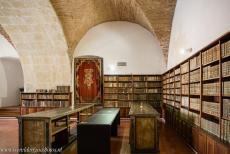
(129, 102, 159, 153)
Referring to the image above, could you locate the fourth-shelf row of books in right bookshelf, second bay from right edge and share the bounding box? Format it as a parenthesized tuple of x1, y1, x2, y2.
(202, 101, 220, 117)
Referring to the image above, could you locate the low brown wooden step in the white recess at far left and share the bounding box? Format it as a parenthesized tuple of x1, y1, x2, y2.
(0, 106, 20, 117)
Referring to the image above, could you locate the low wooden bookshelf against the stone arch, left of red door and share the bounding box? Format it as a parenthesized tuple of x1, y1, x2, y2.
(20, 92, 71, 115)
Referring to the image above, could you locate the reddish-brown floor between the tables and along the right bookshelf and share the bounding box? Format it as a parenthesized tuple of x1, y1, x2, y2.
(63, 119, 194, 154)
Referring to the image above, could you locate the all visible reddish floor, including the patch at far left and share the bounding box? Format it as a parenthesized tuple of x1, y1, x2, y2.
(0, 118, 193, 154)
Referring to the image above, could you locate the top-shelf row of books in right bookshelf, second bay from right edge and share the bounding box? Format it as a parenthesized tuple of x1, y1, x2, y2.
(202, 44, 220, 65)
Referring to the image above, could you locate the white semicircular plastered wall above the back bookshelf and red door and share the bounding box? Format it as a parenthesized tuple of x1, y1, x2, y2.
(74, 21, 166, 74)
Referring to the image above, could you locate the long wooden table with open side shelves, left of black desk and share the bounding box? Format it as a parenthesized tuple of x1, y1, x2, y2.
(18, 104, 94, 153)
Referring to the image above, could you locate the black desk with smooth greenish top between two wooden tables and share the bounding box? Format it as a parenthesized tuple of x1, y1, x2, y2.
(77, 108, 120, 154)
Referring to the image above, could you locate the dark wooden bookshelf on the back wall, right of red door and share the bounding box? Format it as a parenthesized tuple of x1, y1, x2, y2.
(103, 74, 162, 118)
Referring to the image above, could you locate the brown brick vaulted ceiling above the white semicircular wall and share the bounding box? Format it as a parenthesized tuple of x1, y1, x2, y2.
(50, 0, 176, 61)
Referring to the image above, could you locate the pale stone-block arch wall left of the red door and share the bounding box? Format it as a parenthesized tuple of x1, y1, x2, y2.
(0, 0, 71, 91)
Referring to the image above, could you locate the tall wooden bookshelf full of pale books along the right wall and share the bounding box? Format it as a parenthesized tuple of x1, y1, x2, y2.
(163, 32, 230, 152)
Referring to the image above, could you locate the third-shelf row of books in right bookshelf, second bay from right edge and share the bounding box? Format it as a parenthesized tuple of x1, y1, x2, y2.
(203, 82, 220, 96)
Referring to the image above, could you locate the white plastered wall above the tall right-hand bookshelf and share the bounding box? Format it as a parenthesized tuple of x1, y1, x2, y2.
(167, 0, 230, 69)
